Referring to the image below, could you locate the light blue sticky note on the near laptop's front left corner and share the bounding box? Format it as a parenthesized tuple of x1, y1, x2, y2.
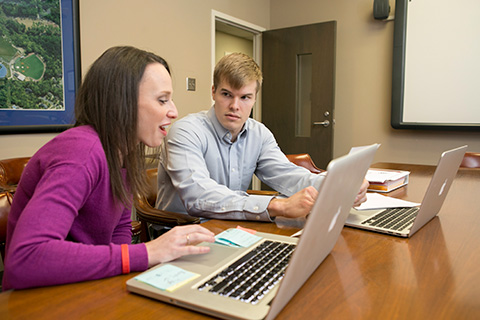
(135, 264, 200, 292)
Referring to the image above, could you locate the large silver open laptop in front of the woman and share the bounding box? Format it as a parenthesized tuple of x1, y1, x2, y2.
(127, 144, 378, 319)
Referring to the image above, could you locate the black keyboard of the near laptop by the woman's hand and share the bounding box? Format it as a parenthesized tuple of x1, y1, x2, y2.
(198, 240, 295, 304)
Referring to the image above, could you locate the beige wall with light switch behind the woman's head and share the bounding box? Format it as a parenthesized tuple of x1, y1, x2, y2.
(0, 0, 270, 158)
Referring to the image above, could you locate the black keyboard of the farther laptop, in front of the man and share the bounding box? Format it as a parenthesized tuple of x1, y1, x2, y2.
(362, 207, 418, 231)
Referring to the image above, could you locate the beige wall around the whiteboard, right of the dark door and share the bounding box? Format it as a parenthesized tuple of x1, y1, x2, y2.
(270, 0, 480, 164)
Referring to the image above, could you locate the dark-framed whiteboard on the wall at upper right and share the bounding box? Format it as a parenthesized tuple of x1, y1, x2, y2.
(392, 0, 480, 130)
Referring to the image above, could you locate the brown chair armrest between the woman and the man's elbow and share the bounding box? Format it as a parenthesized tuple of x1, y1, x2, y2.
(135, 198, 200, 227)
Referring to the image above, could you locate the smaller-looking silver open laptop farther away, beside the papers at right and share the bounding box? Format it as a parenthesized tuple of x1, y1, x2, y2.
(345, 146, 467, 237)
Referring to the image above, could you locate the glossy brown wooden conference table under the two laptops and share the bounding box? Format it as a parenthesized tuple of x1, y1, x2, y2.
(0, 163, 480, 319)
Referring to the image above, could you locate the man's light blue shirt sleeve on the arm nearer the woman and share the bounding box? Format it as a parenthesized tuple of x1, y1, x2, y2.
(163, 126, 273, 221)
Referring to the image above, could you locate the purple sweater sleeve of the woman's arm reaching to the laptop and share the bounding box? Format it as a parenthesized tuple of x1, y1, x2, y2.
(4, 162, 148, 289)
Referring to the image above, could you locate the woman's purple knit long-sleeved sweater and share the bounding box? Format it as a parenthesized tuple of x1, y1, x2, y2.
(3, 126, 148, 290)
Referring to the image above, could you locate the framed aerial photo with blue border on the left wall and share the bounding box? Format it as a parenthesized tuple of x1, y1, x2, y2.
(0, 0, 81, 134)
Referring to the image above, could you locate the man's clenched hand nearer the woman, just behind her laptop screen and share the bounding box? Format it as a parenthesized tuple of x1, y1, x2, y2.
(267, 186, 318, 218)
